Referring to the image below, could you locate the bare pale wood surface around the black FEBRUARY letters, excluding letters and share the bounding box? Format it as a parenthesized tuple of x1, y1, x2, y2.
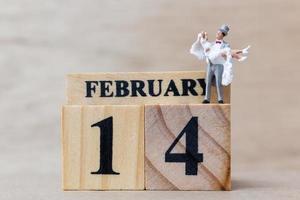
(67, 71, 230, 105)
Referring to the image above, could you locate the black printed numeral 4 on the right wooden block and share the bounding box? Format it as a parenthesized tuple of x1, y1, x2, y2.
(165, 117, 203, 175)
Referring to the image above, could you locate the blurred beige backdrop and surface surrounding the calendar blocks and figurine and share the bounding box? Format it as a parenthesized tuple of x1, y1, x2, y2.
(0, 0, 300, 200)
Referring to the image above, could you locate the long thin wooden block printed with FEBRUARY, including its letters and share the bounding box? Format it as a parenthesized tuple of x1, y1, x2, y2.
(67, 71, 230, 105)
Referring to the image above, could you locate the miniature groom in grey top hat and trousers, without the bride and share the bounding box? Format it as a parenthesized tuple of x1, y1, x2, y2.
(200, 25, 230, 104)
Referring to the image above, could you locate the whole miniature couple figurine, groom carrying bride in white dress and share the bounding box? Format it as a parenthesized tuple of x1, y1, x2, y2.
(190, 25, 250, 104)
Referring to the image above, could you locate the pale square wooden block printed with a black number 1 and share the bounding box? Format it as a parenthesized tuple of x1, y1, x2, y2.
(62, 105, 144, 190)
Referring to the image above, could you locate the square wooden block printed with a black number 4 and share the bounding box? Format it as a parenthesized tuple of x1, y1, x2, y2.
(145, 104, 231, 190)
